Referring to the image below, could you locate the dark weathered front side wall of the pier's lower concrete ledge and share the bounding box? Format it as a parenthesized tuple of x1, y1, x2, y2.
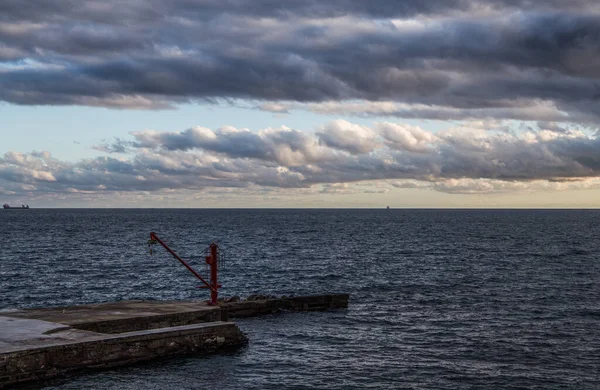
(0, 322, 247, 388)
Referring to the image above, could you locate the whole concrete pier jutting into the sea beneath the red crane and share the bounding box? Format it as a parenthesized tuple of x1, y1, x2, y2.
(0, 294, 348, 388)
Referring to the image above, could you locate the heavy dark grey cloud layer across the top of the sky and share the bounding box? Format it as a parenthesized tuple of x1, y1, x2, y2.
(0, 0, 600, 123)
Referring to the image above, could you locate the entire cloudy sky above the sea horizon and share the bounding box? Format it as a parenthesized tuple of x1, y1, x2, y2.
(0, 0, 600, 208)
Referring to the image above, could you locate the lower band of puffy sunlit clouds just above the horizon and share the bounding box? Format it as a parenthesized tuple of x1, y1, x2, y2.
(0, 120, 600, 200)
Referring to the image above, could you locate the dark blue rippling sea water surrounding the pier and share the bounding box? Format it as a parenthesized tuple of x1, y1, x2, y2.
(0, 209, 600, 389)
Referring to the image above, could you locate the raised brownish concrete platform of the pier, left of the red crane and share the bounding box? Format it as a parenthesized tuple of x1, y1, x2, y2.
(3, 301, 221, 333)
